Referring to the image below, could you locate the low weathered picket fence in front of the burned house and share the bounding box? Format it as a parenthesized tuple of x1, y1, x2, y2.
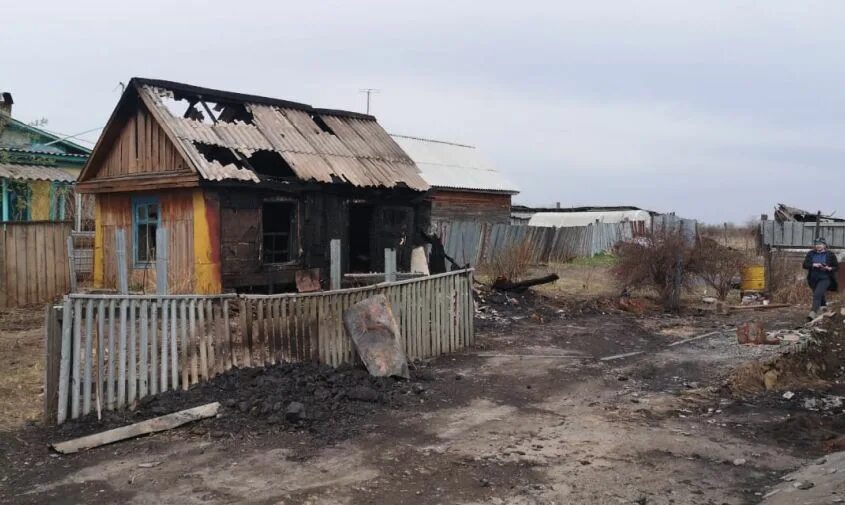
(45, 270, 474, 423)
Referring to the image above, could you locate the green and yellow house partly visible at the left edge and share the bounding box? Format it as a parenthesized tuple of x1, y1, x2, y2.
(0, 93, 90, 222)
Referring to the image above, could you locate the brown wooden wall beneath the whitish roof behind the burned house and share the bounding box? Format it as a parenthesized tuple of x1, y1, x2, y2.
(431, 190, 511, 224)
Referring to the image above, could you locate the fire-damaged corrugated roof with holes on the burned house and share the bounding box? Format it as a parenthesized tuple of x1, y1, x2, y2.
(130, 78, 429, 191)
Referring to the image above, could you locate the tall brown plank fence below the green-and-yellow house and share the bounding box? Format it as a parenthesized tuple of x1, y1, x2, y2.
(0, 221, 71, 308)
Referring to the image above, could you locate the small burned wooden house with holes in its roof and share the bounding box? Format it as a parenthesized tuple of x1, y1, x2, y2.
(78, 78, 430, 293)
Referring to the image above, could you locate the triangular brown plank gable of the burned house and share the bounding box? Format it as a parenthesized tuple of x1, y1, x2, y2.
(95, 104, 189, 178)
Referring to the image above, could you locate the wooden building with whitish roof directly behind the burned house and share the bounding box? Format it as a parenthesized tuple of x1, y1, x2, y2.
(392, 135, 519, 224)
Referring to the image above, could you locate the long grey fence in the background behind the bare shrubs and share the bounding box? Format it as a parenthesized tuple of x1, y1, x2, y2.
(435, 214, 697, 265)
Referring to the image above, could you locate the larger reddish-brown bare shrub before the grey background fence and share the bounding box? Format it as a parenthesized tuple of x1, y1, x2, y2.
(614, 232, 696, 310)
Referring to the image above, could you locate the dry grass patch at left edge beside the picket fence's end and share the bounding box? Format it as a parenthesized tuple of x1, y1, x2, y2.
(0, 307, 44, 431)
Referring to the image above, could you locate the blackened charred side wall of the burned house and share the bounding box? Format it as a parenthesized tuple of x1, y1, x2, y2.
(218, 186, 430, 291)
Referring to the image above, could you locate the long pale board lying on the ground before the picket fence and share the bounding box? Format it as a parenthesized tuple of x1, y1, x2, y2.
(52, 402, 220, 454)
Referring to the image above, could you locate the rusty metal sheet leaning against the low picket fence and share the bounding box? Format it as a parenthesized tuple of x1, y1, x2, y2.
(343, 295, 410, 379)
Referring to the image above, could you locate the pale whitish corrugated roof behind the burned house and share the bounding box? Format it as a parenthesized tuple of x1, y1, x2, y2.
(391, 135, 519, 194)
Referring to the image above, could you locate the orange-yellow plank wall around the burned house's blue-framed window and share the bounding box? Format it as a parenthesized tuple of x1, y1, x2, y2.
(94, 190, 195, 293)
